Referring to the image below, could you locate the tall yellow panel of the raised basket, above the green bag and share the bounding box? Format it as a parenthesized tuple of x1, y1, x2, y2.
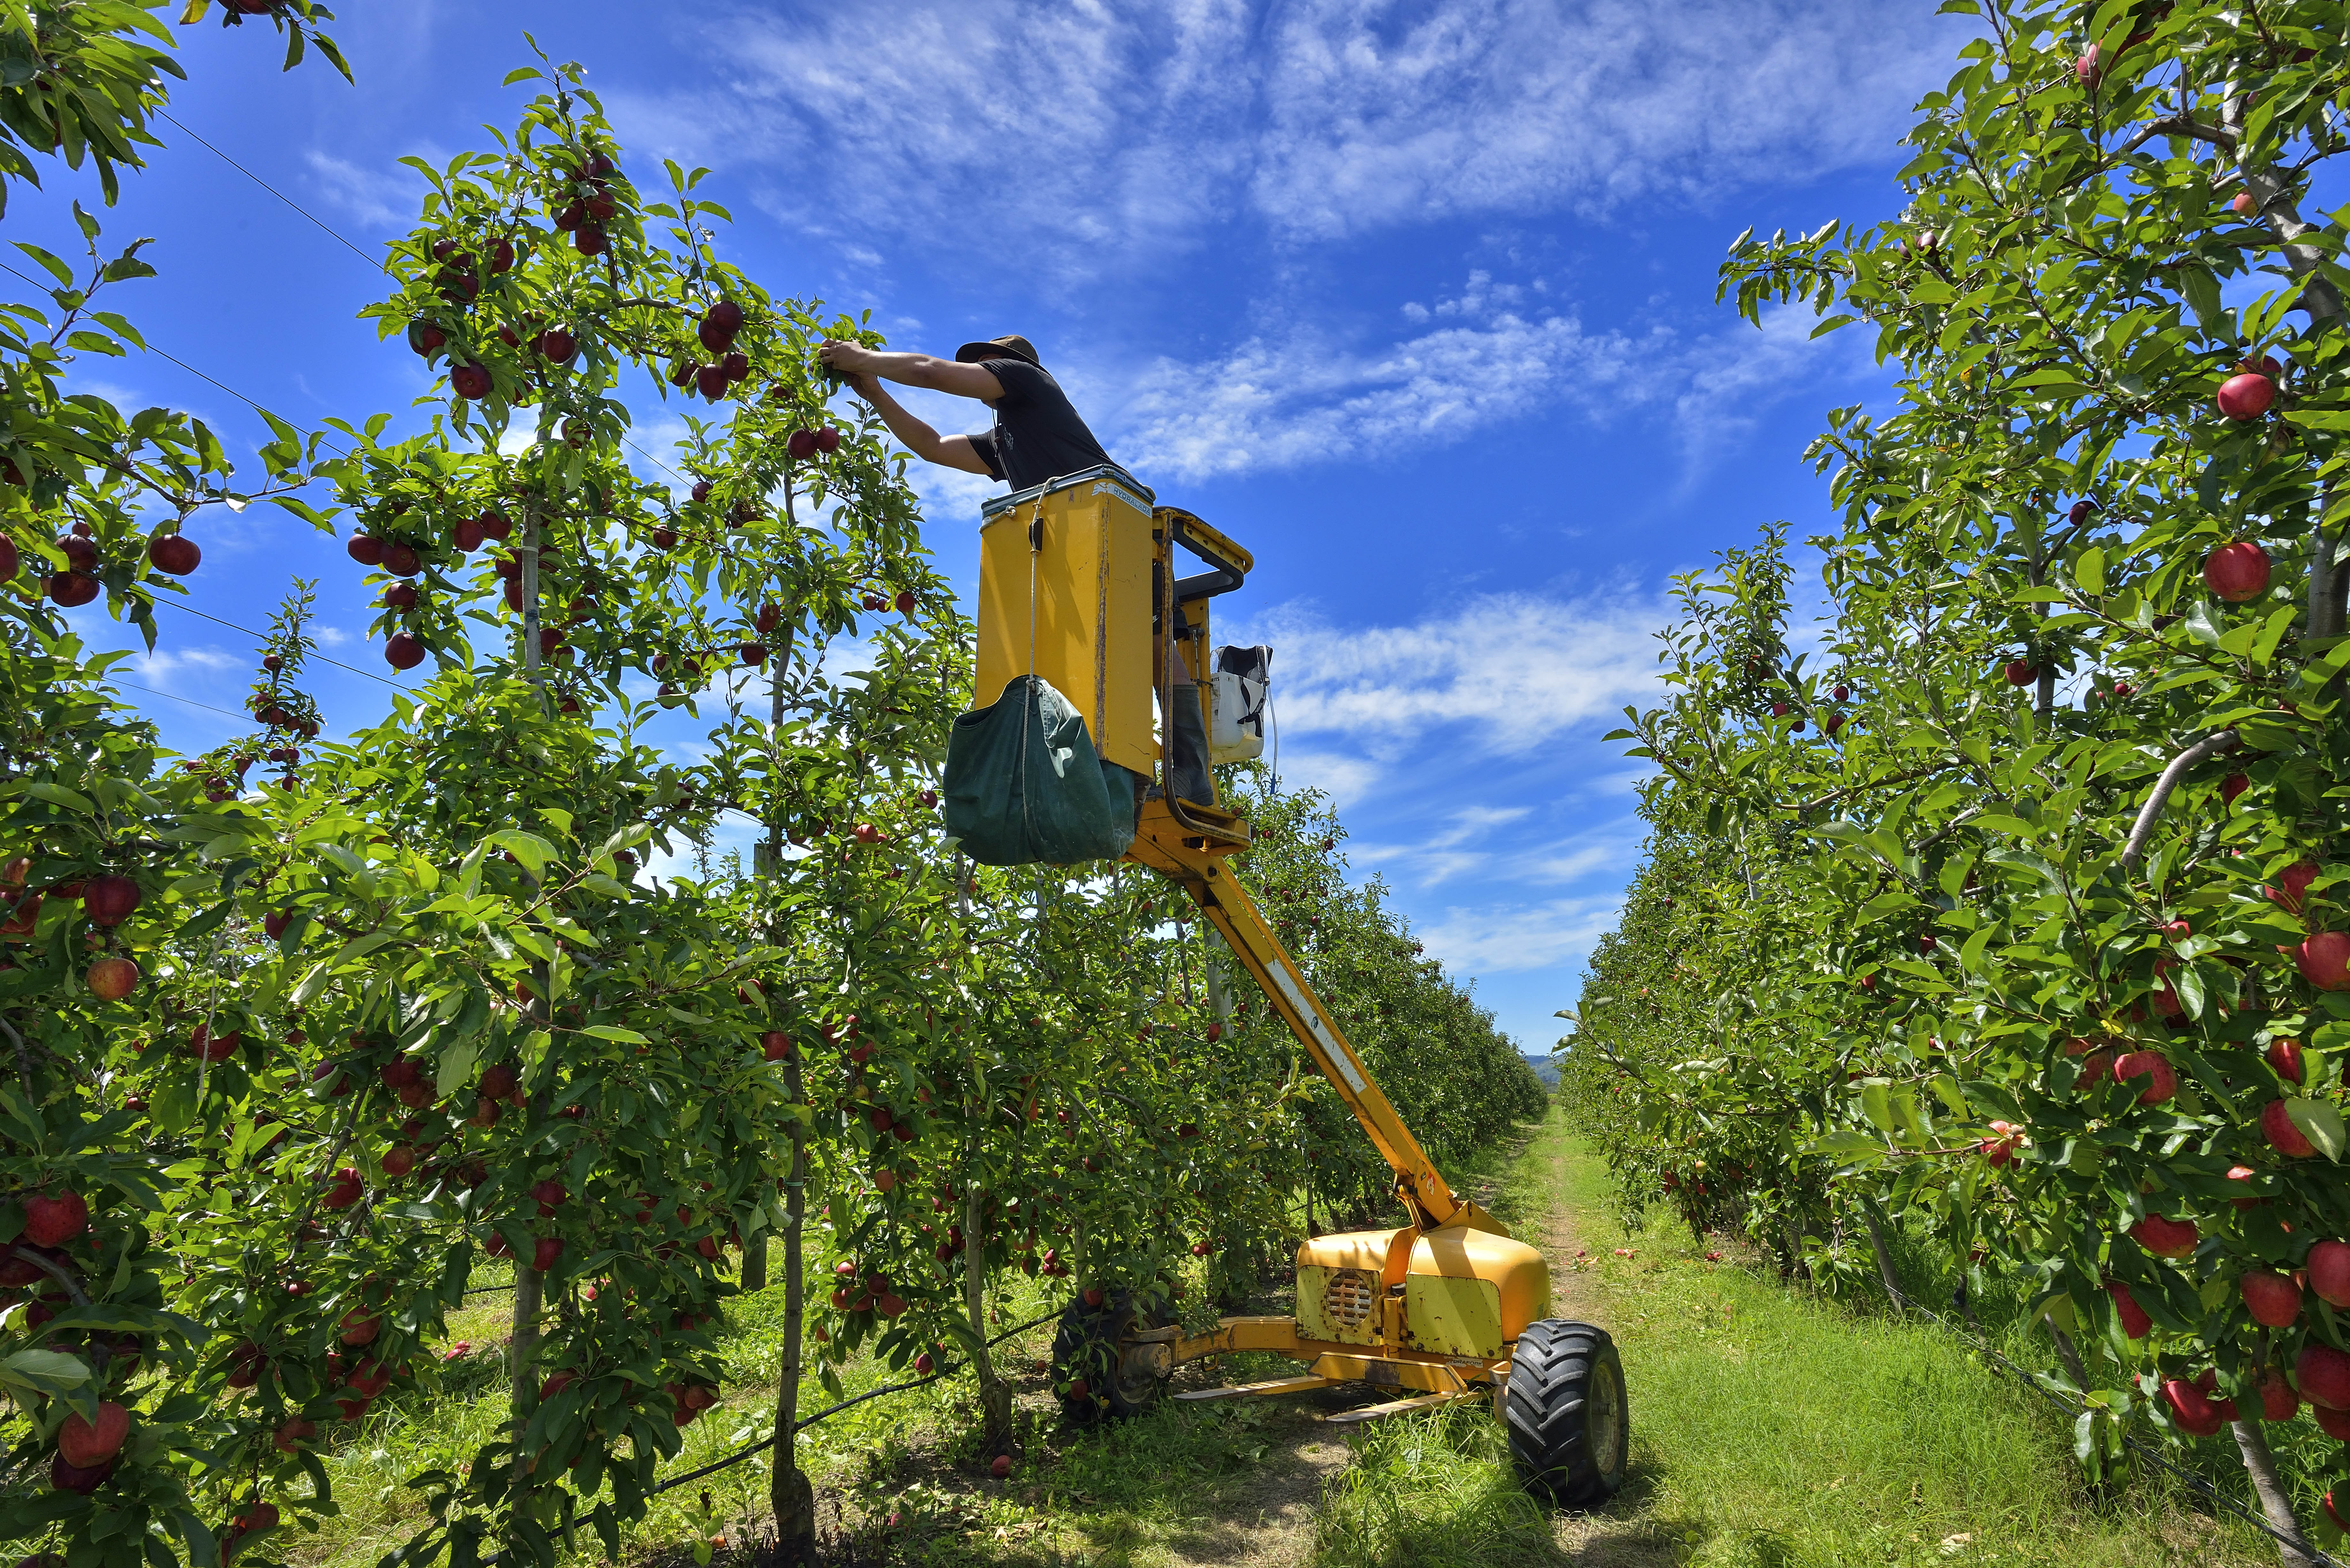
(973, 468, 1158, 778)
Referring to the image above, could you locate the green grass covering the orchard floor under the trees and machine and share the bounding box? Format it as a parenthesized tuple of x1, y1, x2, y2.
(270, 1117, 2275, 1568)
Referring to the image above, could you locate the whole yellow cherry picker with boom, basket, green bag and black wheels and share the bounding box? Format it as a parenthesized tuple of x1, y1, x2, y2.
(945, 465, 1628, 1507)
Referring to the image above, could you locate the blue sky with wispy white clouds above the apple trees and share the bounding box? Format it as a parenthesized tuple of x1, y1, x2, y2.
(7, 0, 1962, 1051)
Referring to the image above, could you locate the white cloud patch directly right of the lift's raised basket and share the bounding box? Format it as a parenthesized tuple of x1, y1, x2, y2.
(1248, 592, 1669, 757)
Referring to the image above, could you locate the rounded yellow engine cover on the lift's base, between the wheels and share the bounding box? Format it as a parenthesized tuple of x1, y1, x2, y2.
(1297, 1225, 1551, 1359)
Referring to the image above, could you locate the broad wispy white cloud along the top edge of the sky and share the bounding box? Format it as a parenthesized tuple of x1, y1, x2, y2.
(630, 0, 1965, 273)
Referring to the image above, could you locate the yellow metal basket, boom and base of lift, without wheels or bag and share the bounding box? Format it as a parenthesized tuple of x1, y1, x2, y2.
(978, 482, 1549, 1420)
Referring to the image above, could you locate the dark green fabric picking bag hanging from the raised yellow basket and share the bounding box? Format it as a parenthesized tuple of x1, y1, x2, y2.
(947, 675, 1135, 865)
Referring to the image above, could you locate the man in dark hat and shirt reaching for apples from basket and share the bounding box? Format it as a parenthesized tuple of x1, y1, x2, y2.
(818, 334, 1109, 489)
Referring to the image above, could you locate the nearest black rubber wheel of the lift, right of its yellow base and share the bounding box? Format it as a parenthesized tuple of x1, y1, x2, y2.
(1502, 1319, 1631, 1507)
